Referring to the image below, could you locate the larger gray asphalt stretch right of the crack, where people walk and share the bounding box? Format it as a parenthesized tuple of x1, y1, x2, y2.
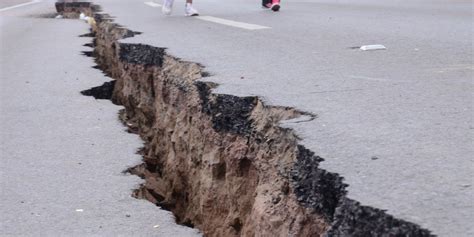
(90, 0, 474, 236)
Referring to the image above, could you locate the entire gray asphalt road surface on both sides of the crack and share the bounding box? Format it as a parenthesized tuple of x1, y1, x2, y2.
(0, 0, 474, 236)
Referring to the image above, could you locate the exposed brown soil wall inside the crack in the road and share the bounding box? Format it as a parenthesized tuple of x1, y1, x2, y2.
(89, 8, 327, 236)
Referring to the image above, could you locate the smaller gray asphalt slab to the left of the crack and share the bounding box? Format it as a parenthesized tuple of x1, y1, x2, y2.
(0, 1, 199, 236)
